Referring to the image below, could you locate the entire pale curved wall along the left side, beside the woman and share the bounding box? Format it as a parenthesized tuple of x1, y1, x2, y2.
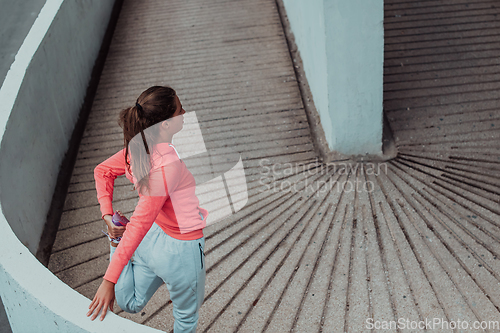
(0, 0, 157, 333)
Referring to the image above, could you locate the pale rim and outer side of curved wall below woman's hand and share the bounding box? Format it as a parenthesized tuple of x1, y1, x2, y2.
(0, 214, 159, 333)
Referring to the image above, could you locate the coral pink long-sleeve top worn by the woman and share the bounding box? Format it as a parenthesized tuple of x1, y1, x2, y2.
(94, 143, 208, 283)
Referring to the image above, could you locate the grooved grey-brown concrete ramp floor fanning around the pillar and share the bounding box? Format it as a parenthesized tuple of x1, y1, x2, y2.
(49, 0, 500, 332)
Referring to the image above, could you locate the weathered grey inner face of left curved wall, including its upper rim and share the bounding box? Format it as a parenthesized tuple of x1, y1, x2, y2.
(0, 0, 114, 253)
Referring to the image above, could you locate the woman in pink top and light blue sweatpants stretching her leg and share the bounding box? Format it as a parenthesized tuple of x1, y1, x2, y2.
(87, 86, 208, 333)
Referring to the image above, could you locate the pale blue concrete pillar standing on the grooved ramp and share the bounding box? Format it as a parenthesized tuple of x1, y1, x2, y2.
(283, 0, 384, 155)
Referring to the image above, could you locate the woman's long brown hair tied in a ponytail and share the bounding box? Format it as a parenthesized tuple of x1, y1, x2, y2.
(118, 86, 177, 193)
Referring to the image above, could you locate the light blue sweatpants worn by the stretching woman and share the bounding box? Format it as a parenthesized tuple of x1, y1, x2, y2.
(110, 223, 205, 333)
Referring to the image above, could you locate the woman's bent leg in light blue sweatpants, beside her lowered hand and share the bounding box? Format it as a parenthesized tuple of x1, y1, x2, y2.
(111, 243, 163, 313)
